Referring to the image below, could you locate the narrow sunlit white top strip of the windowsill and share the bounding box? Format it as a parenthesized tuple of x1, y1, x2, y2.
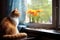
(25, 28, 60, 35)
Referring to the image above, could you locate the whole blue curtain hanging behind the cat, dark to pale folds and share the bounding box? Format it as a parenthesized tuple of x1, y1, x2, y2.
(5, 0, 26, 23)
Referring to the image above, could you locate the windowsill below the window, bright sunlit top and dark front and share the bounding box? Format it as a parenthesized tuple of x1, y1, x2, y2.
(21, 28, 60, 39)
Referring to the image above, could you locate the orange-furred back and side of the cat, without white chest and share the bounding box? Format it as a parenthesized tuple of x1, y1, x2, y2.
(1, 17, 16, 34)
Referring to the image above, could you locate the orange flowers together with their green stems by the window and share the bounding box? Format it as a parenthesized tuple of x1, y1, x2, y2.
(26, 9, 44, 22)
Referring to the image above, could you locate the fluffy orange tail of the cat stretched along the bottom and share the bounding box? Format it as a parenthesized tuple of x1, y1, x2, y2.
(3, 33, 27, 39)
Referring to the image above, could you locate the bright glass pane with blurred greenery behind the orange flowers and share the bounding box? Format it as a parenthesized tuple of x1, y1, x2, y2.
(25, 0, 52, 24)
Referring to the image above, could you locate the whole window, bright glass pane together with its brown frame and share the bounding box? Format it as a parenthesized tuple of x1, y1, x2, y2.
(19, 0, 56, 28)
